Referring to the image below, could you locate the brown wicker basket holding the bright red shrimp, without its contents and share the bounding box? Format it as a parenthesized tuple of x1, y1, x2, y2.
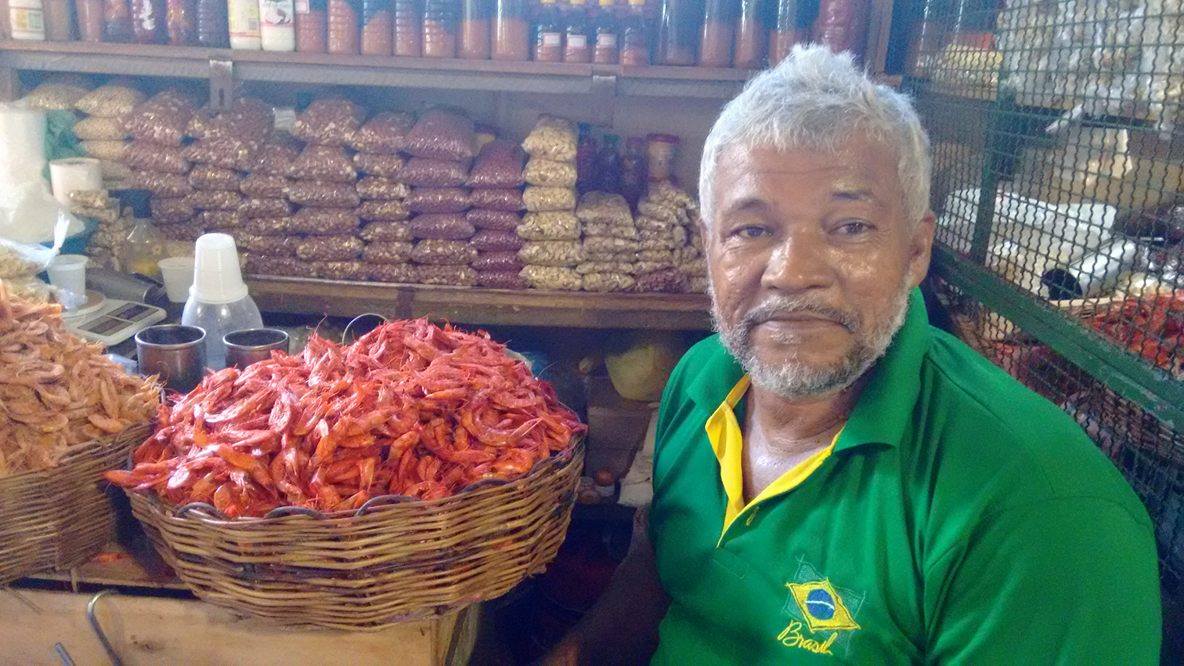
(128, 443, 584, 630)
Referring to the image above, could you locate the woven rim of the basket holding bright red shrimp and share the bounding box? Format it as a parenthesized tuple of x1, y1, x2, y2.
(132, 435, 584, 527)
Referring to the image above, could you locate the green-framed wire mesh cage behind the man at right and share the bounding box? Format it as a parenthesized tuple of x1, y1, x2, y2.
(905, 0, 1184, 583)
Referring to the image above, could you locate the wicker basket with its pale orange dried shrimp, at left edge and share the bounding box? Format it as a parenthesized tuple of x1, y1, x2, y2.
(0, 281, 160, 584)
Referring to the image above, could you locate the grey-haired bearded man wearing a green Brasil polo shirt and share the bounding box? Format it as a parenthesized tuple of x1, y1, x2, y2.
(554, 47, 1160, 665)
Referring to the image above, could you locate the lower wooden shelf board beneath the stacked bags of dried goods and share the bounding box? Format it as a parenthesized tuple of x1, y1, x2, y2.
(247, 277, 710, 331)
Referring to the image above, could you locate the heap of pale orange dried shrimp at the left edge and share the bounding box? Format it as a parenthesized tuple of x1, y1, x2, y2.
(0, 280, 160, 476)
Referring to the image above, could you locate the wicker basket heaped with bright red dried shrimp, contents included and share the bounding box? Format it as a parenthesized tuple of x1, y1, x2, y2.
(108, 320, 584, 629)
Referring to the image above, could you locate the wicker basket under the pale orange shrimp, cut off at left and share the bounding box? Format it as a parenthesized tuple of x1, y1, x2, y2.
(0, 424, 148, 585)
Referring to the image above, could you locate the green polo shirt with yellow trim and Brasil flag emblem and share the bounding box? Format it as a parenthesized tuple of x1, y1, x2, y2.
(650, 292, 1160, 665)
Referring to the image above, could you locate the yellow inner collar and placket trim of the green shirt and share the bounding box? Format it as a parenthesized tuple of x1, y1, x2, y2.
(704, 374, 838, 540)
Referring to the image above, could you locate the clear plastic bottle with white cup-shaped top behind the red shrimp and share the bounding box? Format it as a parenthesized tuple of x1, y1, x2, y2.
(181, 233, 263, 370)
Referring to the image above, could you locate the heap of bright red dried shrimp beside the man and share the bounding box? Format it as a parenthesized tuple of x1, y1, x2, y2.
(107, 320, 585, 517)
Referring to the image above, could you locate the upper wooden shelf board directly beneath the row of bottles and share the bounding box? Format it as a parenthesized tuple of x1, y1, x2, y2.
(0, 40, 752, 100)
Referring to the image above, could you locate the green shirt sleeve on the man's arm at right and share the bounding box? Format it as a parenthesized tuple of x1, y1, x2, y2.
(924, 497, 1162, 664)
